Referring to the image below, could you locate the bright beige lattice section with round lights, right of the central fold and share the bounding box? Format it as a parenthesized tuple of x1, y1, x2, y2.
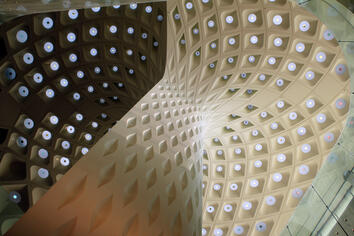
(180, 1, 349, 235)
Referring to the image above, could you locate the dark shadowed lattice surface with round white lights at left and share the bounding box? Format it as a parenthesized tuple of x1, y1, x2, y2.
(0, 3, 166, 211)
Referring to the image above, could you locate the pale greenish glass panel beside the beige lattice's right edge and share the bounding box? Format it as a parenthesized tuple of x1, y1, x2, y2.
(281, 0, 354, 236)
